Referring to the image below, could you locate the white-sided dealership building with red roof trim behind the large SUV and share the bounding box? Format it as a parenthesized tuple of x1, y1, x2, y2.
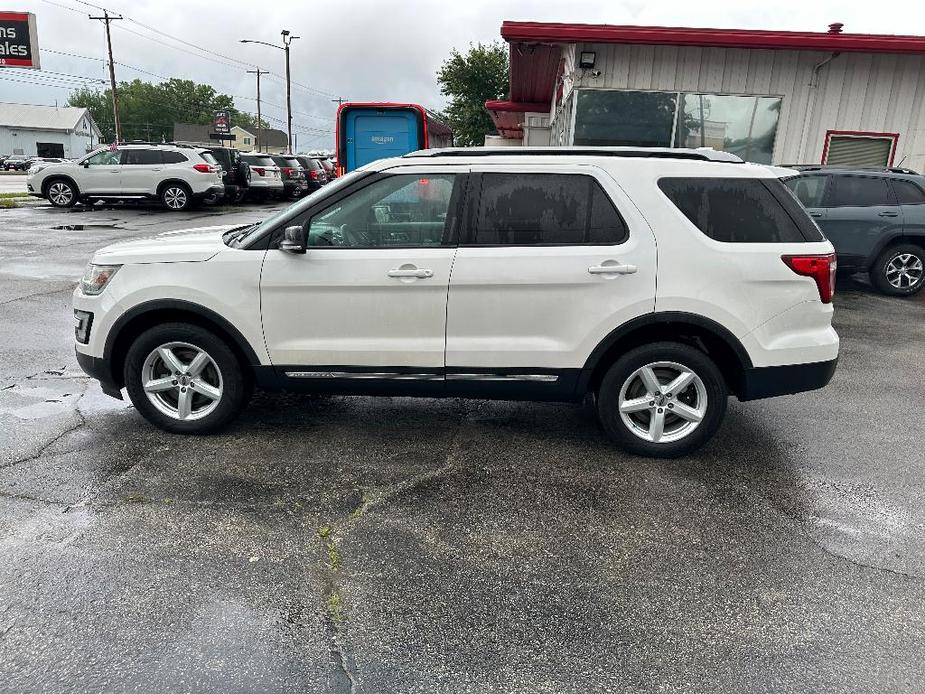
(485, 22, 925, 171)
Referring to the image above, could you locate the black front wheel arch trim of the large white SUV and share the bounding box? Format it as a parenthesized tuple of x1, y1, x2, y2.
(103, 299, 260, 387)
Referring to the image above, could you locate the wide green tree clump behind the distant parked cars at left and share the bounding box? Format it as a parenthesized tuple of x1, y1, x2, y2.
(68, 78, 270, 142)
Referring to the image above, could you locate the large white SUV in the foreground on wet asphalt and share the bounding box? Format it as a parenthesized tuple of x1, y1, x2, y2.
(74, 148, 838, 457)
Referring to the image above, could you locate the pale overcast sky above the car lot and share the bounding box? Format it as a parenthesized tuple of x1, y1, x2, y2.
(0, 0, 925, 149)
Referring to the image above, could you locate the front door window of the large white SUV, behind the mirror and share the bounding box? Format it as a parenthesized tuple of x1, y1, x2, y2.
(308, 174, 456, 248)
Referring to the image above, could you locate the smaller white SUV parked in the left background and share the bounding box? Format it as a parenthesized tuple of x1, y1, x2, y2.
(26, 144, 225, 211)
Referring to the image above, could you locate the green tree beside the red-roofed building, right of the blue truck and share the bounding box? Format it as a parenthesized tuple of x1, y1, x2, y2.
(437, 42, 508, 147)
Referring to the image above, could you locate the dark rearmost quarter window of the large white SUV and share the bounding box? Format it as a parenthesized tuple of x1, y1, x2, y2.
(658, 178, 823, 243)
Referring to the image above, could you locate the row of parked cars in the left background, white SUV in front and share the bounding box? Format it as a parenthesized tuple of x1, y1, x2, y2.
(26, 142, 333, 210)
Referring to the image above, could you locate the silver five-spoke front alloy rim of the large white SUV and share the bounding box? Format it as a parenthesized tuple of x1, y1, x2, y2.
(141, 342, 223, 421)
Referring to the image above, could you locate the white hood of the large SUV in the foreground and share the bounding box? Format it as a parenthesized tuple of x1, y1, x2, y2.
(92, 224, 241, 265)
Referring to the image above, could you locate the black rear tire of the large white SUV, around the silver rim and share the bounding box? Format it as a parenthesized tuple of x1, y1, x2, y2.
(597, 342, 728, 458)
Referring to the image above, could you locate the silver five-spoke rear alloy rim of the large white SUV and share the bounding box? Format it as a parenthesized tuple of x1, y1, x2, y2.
(618, 361, 707, 443)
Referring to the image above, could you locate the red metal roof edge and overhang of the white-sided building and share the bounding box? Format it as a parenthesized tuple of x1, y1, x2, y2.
(485, 22, 925, 138)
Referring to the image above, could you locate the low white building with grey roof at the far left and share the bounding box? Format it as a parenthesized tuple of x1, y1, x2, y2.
(0, 103, 100, 158)
